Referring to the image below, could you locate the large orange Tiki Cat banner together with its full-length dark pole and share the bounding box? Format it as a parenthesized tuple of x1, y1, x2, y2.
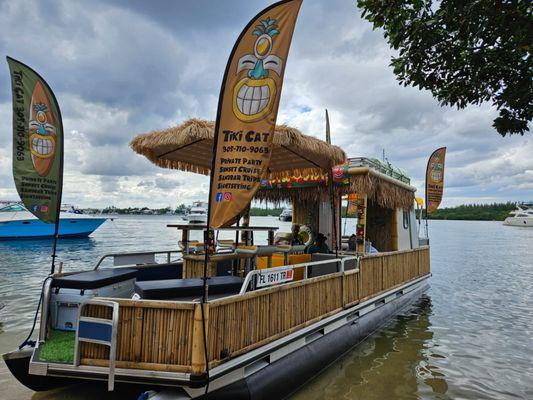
(201, 0, 301, 395)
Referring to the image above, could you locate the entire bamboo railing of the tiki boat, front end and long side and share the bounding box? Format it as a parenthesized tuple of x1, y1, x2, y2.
(81, 247, 430, 374)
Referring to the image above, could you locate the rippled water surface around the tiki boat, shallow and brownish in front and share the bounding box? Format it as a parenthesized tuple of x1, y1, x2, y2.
(0, 216, 533, 400)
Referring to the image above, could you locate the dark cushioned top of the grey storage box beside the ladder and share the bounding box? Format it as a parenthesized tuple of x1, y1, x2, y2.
(52, 268, 137, 290)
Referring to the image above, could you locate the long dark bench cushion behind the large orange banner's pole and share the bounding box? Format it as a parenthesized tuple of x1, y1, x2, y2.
(135, 276, 244, 300)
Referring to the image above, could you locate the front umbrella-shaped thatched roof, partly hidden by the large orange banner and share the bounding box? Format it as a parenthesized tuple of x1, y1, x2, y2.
(130, 119, 346, 178)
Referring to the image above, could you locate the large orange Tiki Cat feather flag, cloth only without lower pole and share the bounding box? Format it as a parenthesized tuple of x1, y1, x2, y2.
(208, 0, 302, 229)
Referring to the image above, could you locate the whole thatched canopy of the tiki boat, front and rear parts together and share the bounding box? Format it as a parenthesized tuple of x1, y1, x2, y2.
(130, 119, 416, 209)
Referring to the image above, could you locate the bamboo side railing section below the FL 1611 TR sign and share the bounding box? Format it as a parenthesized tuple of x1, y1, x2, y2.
(208, 272, 343, 361)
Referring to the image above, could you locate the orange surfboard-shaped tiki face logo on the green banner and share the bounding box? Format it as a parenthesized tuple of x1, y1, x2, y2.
(29, 81, 56, 176)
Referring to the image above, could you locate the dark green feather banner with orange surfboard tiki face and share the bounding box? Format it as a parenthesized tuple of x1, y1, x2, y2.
(7, 57, 63, 225)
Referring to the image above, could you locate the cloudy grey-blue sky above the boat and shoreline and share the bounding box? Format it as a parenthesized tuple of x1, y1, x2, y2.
(0, 0, 533, 207)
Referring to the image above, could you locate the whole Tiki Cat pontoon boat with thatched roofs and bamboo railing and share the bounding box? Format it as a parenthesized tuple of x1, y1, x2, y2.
(4, 120, 430, 399)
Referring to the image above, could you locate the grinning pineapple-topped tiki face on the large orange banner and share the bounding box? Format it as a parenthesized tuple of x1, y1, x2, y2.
(233, 18, 283, 122)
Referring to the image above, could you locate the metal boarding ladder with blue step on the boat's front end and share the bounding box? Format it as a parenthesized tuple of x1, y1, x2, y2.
(74, 299, 118, 391)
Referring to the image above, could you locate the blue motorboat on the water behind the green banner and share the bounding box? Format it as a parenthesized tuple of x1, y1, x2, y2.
(0, 203, 107, 240)
